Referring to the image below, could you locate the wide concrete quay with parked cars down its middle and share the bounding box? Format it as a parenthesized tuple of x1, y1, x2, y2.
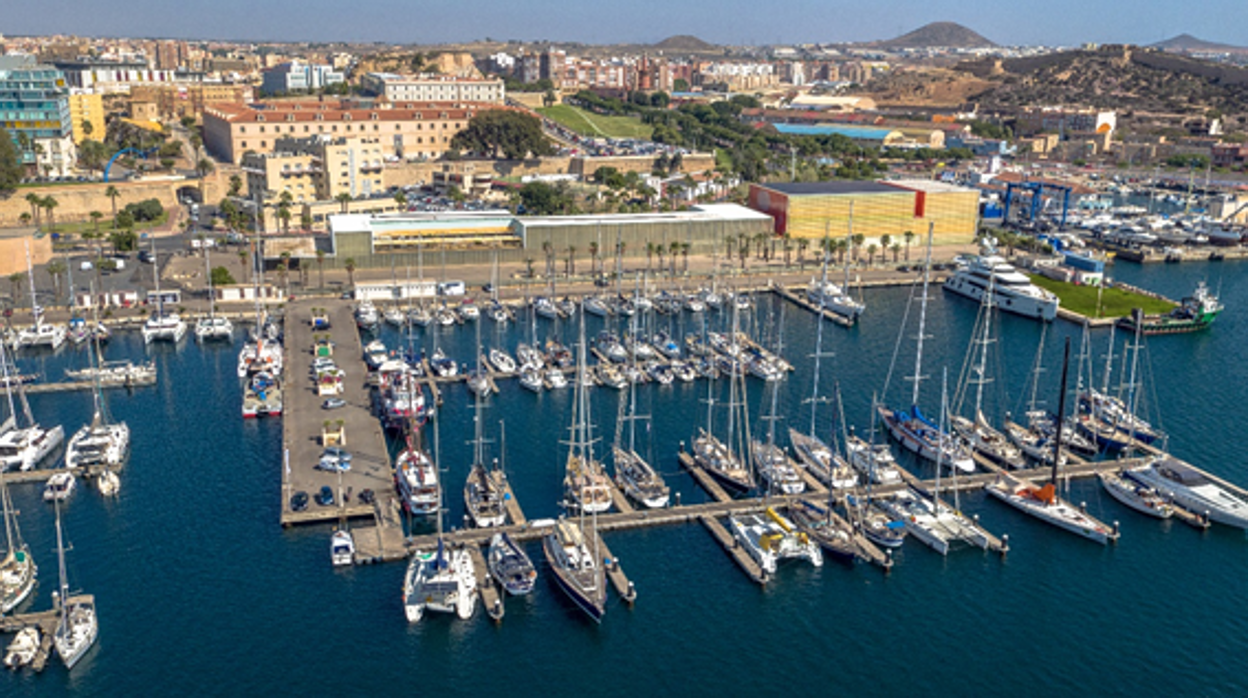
(278, 300, 397, 526)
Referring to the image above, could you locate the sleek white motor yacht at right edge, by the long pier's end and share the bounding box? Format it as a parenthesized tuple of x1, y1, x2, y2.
(1122, 453, 1248, 529)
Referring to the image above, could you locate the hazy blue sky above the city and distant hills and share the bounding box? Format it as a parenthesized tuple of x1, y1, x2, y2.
(9, 0, 1248, 45)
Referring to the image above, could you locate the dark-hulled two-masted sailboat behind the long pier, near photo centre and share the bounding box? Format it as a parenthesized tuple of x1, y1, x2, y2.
(693, 306, 754, 494)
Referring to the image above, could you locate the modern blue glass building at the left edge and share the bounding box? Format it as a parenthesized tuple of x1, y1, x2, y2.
(0, 56, 74, 165)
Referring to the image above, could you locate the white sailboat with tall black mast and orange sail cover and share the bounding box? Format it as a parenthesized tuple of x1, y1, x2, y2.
(985, 337, 1118, 544)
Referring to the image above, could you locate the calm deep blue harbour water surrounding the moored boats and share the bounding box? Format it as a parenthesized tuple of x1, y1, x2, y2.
(0, 263, 1248, 696)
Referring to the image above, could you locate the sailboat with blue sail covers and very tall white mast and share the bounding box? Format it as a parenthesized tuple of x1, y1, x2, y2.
(877, 224, 975, 472)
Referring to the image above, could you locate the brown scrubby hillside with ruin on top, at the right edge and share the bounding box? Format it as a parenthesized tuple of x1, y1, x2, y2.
(958, 46, 1248, 114)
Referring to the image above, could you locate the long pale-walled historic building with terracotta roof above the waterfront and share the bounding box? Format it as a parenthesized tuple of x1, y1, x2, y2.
(203, 100, 507, 164)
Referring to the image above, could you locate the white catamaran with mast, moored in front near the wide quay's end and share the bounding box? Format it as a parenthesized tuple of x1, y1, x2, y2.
(403, 412, 477, 623)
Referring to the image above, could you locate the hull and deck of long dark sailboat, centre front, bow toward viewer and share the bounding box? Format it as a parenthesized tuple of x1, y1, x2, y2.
(542, 519, 607, 623)
